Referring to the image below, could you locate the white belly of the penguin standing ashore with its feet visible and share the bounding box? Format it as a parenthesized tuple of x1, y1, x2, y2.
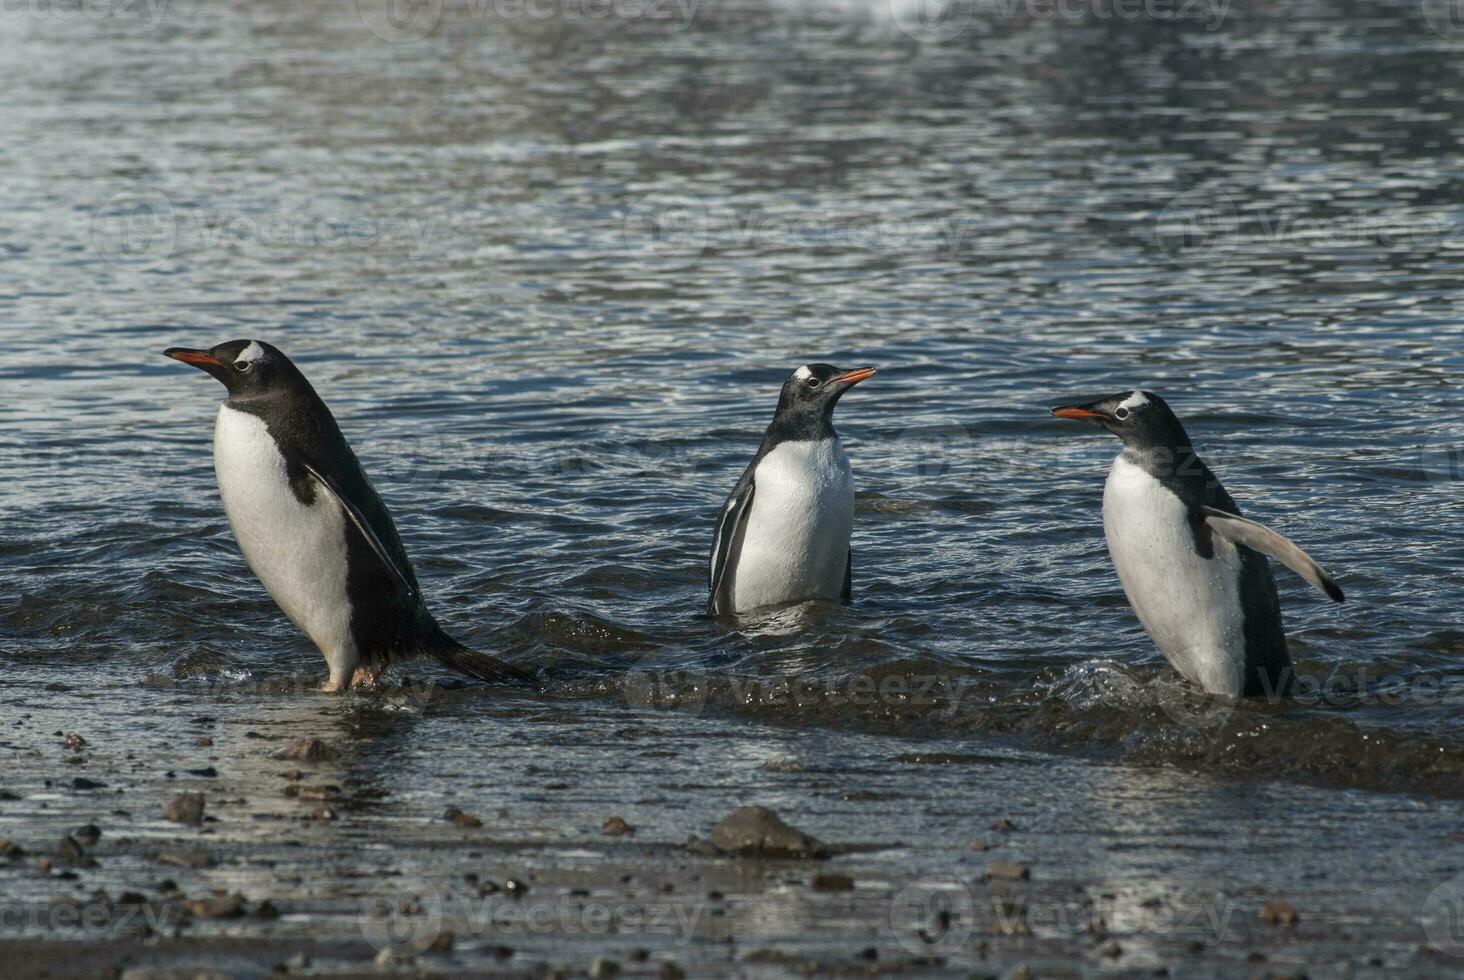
(214, 404, 356, 667)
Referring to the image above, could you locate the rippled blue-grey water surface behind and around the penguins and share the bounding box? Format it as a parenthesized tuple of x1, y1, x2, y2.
(0, 0, 1464, 814)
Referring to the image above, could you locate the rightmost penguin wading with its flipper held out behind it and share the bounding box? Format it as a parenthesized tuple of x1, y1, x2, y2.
(1053, 391, 1342, 696)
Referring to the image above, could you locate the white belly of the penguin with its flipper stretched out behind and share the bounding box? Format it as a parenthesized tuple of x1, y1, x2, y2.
(1102, 456, 1246, 696)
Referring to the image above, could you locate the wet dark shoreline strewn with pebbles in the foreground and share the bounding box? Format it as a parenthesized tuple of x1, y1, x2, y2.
(0, 667, 1464, 977)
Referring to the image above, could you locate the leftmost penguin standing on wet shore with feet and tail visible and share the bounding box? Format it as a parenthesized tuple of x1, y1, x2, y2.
(164, 340, 531, 691)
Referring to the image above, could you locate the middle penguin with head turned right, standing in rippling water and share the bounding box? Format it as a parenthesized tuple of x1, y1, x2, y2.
(709, 365, 874, 615)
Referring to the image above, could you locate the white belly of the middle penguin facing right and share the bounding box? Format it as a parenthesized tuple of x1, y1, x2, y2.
(729, 439, 854, 612)
